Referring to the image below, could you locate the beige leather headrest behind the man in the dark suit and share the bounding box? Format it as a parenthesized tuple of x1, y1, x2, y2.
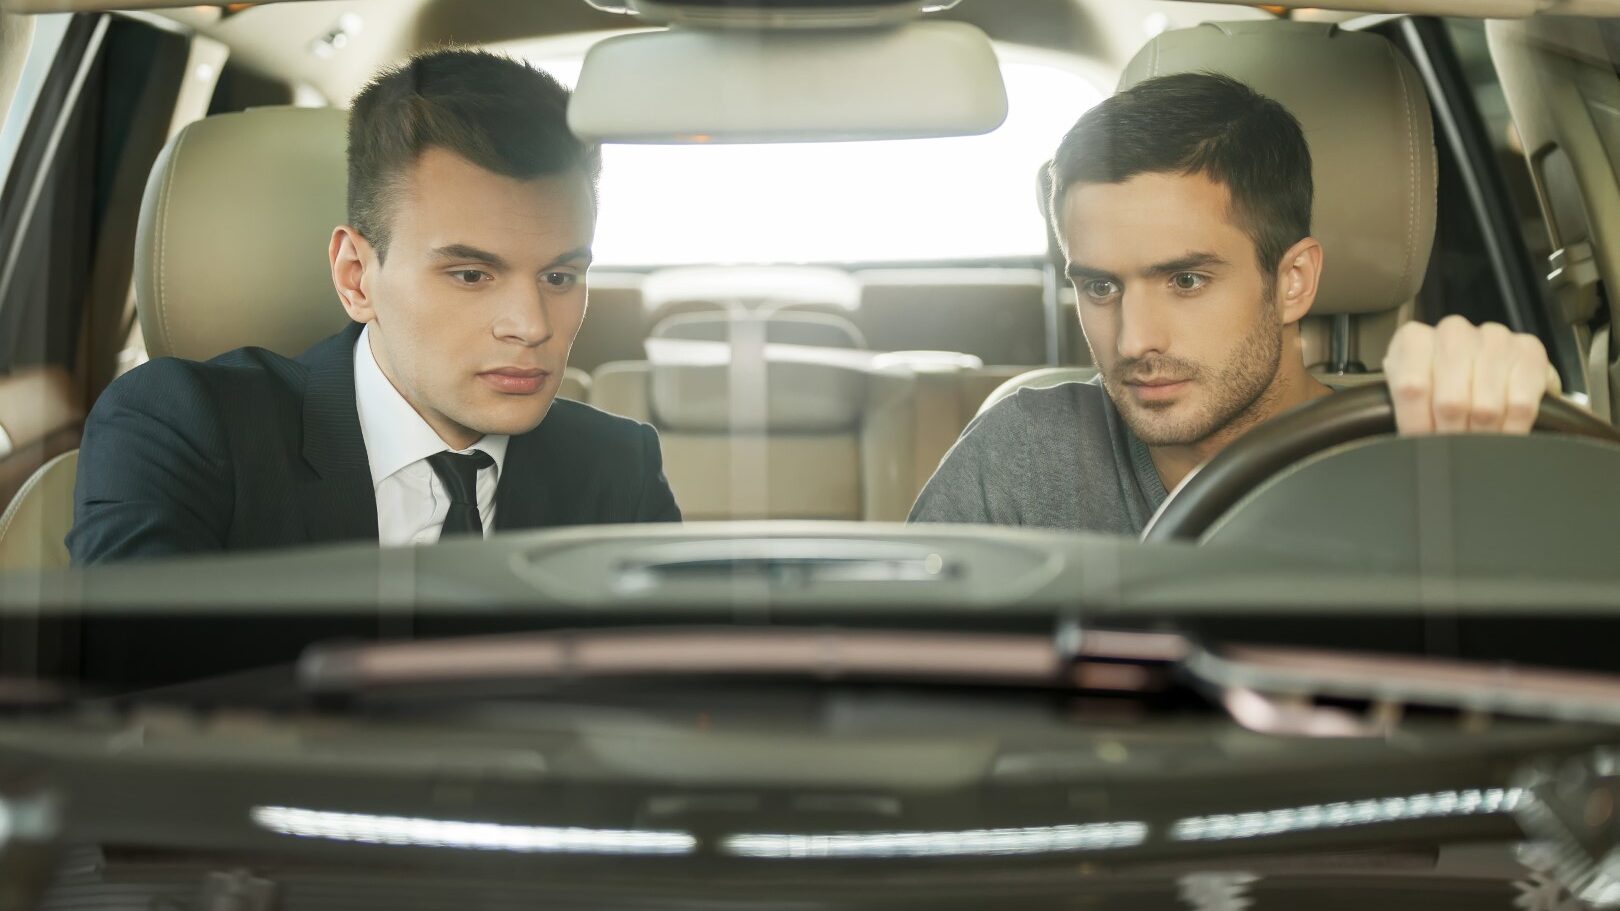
(134, 107, 348, 360)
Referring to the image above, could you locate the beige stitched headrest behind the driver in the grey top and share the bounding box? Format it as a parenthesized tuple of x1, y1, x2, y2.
(1119, 21, 1437, 314)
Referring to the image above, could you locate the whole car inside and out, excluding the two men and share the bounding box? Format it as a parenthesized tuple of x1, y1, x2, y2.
(0, 0, 1620, 911)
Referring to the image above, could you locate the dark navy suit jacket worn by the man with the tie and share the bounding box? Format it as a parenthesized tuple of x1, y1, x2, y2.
(68, 324, 680, 564)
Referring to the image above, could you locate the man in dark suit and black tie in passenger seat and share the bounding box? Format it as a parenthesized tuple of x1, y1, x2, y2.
(68, 50, 680, 564)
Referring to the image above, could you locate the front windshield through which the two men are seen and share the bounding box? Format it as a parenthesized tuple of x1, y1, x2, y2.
(0, 3, 1617, 615)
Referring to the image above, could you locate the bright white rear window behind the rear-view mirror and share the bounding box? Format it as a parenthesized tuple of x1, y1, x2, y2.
(531, 45, 1103, 266)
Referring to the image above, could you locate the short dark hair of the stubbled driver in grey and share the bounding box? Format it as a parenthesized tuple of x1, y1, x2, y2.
(1050, 73, 1312, 274)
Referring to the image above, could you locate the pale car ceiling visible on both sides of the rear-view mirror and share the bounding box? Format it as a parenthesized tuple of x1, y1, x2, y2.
(145, 0, 1268, 104)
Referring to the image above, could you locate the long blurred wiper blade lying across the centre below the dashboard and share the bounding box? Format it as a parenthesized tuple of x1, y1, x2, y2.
(298, 627, 1187, 694)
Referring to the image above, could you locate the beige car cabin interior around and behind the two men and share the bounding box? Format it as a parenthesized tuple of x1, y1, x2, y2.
(0, 0, 1620, 567)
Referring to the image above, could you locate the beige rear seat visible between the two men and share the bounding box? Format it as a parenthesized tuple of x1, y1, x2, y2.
(591, 311, 1024, 520)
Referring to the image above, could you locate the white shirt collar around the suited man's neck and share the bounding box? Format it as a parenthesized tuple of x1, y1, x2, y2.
(355, 324, 510, 486)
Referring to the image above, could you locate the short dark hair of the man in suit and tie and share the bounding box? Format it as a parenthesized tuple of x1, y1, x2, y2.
(348, 49, 601, 258)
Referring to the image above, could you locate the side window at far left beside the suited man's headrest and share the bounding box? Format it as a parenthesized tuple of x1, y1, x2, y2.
(0, 13, 191, 503)
